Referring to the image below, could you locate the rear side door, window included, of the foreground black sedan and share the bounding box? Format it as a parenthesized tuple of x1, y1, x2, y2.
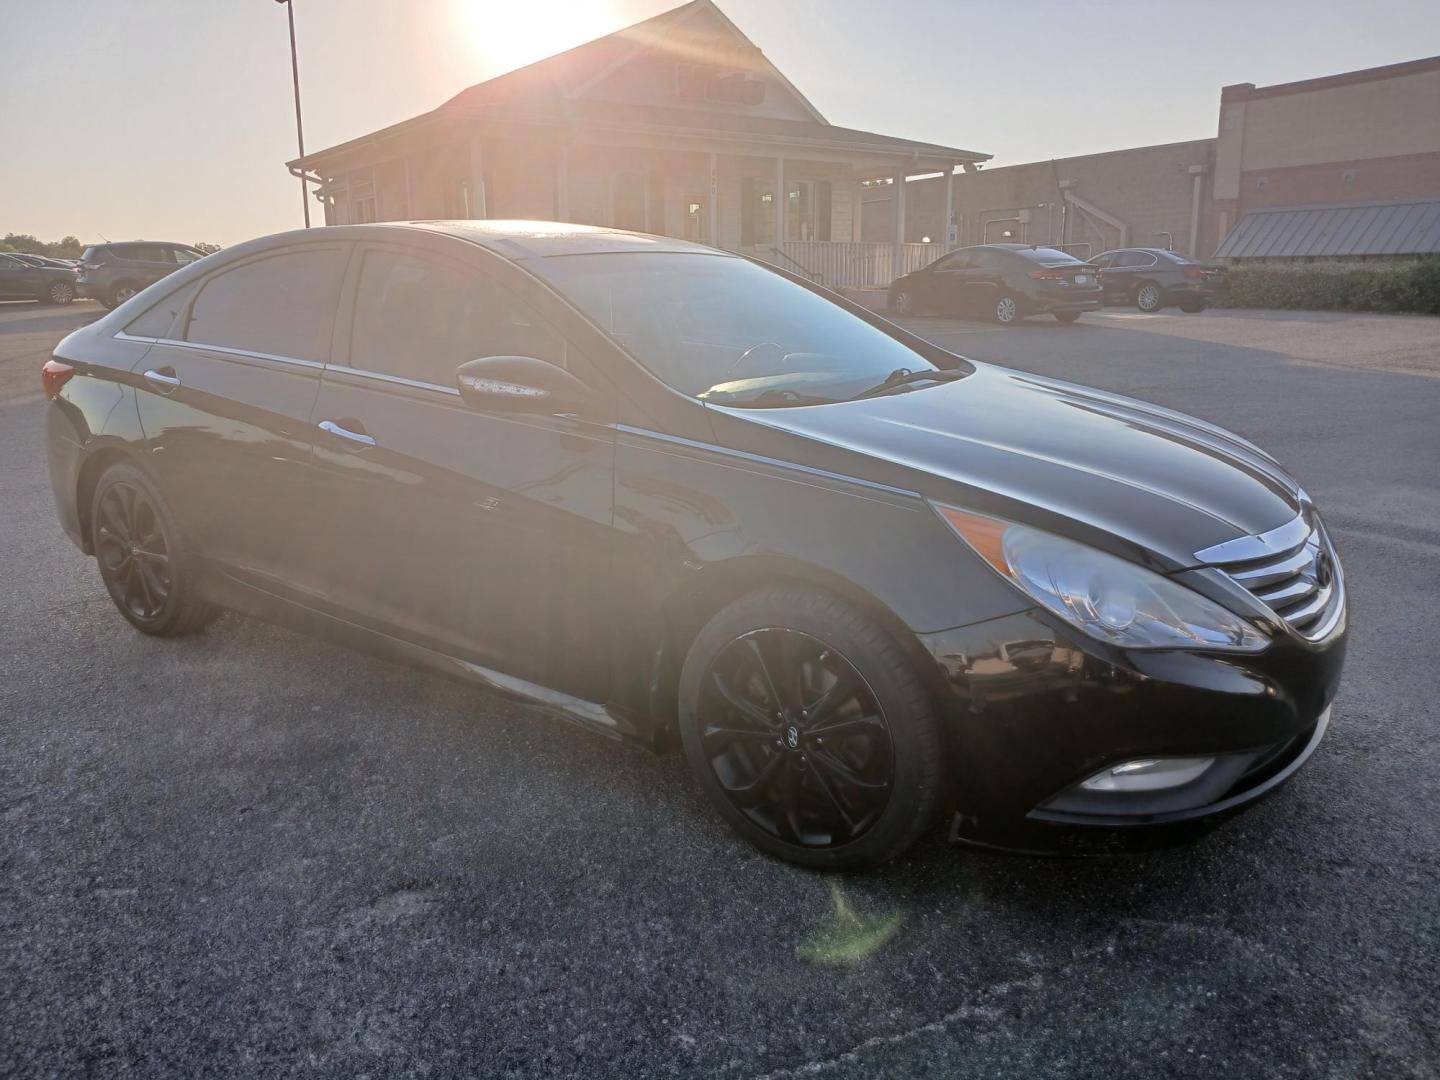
(134, 242, 351, 595)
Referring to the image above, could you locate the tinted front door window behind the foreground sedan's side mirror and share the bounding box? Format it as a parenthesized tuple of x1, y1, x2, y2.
(350, 251, 566, 386)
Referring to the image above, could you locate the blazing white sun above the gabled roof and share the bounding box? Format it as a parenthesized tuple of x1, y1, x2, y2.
(454, 0, 622, 75)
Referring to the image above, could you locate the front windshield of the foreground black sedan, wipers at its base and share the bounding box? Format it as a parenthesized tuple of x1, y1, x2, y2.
(531, 252, 956, 406)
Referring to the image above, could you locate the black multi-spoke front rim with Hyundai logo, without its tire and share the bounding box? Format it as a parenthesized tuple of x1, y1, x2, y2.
(700, 628, 894, 847)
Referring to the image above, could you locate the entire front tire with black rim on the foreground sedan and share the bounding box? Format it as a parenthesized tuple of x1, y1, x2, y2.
(680, 586, 943, 870)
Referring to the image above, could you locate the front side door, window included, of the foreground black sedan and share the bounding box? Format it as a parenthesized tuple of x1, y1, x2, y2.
(306, 243, 615, 700)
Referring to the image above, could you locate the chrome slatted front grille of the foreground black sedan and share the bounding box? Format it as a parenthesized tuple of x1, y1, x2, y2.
(1195, 507, 1345, 641)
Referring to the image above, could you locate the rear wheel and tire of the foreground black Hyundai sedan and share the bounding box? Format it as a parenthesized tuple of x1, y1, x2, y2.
(89, 464, 219, 638)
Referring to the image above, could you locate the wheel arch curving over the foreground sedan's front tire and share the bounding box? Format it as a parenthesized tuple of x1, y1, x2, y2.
(649, 556, 935, 747)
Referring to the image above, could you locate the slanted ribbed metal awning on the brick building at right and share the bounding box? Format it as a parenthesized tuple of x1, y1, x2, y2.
(1215, 199, 1440, 259)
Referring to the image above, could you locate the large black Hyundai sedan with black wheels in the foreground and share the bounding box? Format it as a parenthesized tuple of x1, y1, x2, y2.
(45, 222, 1345, 867)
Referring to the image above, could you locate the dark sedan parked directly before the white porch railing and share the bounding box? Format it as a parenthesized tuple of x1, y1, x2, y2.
(890, 243, 1102, 325)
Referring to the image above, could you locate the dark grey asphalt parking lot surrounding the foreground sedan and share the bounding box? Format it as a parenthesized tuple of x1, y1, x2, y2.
(8, 304, 1440, 1077)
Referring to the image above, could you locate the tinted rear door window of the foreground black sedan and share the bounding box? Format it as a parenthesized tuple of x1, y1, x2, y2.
(184, 248, 346, 361)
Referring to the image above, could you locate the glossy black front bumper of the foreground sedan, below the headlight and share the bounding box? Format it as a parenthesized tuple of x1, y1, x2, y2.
(920, 612, 1345, 854)
